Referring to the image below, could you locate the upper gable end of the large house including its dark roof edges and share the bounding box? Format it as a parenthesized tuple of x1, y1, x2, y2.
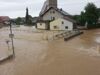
(40, 7, 69, 20)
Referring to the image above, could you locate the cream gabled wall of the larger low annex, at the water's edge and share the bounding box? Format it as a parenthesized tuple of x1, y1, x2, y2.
(50, 18, 73, 30)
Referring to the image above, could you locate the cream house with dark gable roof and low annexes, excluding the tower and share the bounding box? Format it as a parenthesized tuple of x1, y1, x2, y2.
(37, 7, 76, 30)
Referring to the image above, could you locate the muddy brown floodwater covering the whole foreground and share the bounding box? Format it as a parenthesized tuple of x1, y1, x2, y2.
(0, 29, 100, 75)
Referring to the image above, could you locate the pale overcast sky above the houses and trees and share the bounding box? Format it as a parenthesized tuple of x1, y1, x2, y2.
(0, 0, 100, 18)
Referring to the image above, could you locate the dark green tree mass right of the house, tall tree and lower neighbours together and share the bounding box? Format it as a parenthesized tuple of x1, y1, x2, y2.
(73, 3, 100, 28)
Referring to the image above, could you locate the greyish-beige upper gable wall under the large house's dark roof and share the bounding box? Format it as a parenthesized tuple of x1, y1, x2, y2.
(43, 9, 63, 20)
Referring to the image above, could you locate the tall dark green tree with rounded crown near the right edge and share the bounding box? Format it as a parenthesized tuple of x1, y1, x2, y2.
(85, 3, 99, 25)
